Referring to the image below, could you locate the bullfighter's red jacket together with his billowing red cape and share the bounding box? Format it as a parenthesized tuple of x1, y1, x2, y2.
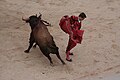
(59, 15, 84, 43)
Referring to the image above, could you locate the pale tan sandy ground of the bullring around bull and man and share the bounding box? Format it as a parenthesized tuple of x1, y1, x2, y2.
(0, 0, 120, 80)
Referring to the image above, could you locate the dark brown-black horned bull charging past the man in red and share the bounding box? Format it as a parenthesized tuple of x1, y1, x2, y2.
(23, 15, 65, 64)
